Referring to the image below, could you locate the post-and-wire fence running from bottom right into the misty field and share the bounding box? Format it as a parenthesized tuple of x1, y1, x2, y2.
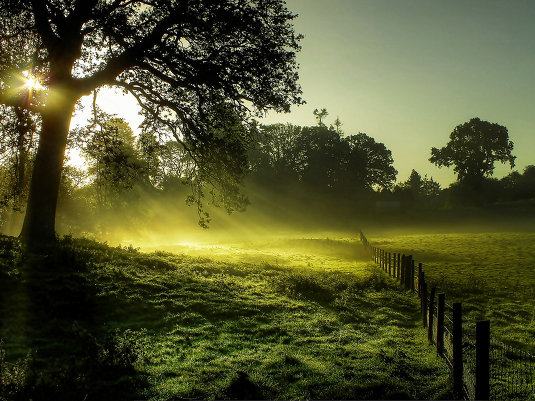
(360, 232, 535, 401)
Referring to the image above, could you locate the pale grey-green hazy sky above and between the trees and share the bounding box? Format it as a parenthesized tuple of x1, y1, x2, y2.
(72, 0, 535, 186)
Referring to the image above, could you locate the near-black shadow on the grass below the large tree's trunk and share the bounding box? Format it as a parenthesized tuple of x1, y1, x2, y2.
(0, 234, 149, 400)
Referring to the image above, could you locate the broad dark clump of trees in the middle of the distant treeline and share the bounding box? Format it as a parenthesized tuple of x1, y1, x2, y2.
(249, 124, 397, 194)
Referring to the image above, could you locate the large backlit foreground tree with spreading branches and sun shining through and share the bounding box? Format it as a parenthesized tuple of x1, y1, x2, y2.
(0, 0, 302, 242)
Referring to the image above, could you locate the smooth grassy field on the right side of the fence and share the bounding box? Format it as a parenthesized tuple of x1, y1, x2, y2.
(368, 232, 535, 353)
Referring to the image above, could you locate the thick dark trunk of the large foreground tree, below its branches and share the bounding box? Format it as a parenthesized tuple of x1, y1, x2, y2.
(20, 100, 75, 246)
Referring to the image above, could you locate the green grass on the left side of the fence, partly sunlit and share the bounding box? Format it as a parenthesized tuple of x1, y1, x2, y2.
(0, 237, 450, 400)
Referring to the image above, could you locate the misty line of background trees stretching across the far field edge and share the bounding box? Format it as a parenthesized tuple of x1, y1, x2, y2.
(0, 102, 535, 234)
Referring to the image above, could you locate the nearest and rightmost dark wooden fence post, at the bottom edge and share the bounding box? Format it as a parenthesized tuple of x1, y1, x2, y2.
(476, 320, 490, 400)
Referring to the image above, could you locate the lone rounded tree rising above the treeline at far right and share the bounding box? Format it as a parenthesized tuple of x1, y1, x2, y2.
(429, 118, 515, 187)
